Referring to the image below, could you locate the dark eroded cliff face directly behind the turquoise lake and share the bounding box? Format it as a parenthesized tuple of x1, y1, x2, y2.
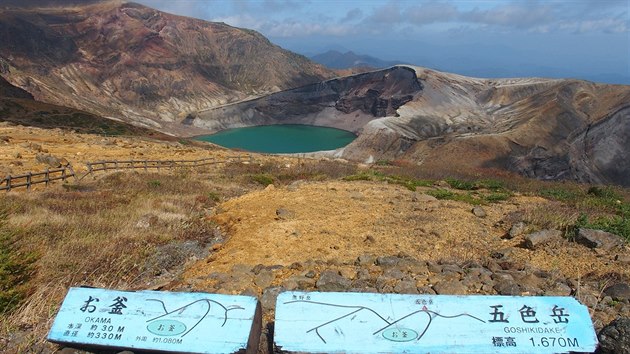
(195, 67, 422, 133)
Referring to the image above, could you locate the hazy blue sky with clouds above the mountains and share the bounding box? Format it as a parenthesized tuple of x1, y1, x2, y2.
(134, 0, 630, 84)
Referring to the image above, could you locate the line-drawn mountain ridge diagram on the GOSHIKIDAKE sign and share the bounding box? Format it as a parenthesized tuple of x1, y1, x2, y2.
(284, 300, 486, 343)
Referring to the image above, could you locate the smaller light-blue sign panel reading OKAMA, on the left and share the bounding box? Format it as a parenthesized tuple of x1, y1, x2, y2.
(48, 288, 261, 353)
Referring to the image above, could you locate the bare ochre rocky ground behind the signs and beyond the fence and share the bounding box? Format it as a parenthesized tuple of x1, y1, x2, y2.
(0, 125, 630, 353)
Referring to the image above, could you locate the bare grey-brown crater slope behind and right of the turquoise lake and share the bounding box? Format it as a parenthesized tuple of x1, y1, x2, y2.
(194, 66, 630, 186)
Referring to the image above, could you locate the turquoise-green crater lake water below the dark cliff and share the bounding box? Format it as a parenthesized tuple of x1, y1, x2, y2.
(195, 124, 356, 154)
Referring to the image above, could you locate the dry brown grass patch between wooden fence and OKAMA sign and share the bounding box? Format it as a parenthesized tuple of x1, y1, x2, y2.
(0, 168, 252, 348)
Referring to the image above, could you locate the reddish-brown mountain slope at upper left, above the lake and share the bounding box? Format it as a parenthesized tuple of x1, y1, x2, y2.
(0, 1, 333, 134)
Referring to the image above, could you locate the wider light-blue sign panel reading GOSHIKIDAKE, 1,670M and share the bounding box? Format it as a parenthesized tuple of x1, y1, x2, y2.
(274, 292, 597, 354)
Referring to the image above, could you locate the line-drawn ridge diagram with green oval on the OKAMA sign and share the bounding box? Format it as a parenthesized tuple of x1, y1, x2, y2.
(146, 299, 244, 337)
